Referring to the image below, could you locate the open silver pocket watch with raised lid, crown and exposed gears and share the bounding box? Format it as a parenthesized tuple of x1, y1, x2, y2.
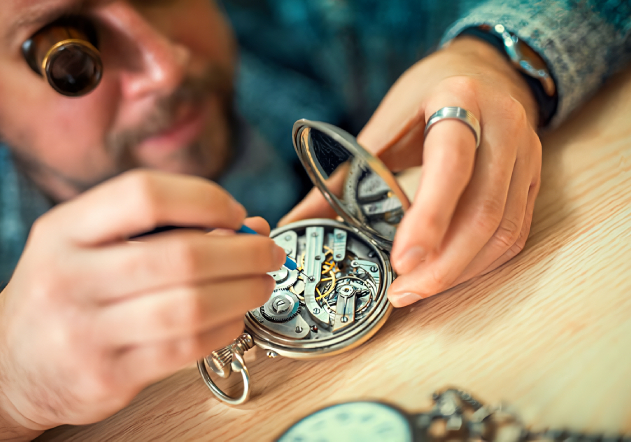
(197, 120, 410, 405)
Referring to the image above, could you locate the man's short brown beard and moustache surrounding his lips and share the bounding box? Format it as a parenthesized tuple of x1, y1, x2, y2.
(11, 65, 236, 201)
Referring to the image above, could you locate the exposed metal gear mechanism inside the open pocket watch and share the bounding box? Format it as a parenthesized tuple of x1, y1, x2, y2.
(250, 222, 387, 343)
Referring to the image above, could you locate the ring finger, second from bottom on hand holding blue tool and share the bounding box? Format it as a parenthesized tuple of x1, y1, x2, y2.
(97, 275, 275, 348)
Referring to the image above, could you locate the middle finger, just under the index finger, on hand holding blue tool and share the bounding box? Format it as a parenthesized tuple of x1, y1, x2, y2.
(87, 230, 286, 303)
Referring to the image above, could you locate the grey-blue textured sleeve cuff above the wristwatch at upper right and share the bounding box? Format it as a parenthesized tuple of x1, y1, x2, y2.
(441, 0, 631, 126)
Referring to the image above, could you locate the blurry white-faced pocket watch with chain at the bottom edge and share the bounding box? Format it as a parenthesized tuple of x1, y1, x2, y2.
(276, 388, 631, 442)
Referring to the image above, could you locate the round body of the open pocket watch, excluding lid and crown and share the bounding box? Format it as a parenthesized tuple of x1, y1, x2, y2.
(246, 220, 392, 358)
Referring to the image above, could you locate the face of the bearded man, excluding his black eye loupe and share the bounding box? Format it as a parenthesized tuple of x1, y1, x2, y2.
(0, 0, 235, 200)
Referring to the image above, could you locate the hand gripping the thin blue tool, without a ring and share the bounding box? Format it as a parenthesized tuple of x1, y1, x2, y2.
(0, 171, 285, 439)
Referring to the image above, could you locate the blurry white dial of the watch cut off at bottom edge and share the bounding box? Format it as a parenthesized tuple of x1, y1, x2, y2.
(278, 401, 413, 442)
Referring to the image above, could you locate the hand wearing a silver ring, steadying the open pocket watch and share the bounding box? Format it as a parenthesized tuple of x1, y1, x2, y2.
(282, 37, 541, 307)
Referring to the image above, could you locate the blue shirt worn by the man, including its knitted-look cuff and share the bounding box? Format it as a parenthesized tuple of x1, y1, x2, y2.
(0, 0, 631, 287)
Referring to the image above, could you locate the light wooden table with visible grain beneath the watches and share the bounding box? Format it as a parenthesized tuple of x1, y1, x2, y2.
(41, 70, 631, 441)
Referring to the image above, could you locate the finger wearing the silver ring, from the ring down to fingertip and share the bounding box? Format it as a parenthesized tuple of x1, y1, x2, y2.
(392, 120, 476, 274)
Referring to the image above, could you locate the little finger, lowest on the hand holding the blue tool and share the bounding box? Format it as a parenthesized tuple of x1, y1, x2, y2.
(112, 319, 243, 391)
